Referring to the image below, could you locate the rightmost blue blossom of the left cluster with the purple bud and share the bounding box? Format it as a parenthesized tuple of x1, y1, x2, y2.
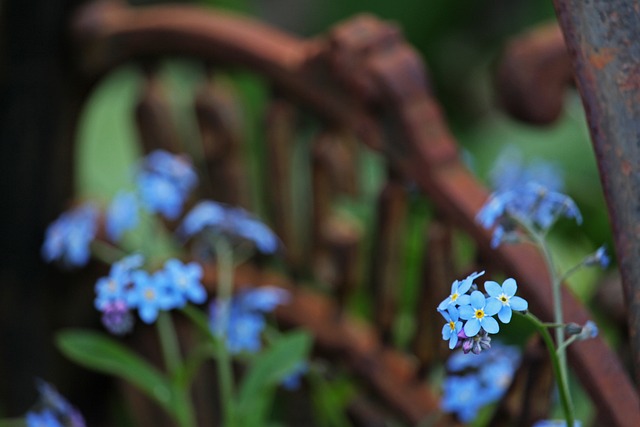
(163, 259, 207, 307)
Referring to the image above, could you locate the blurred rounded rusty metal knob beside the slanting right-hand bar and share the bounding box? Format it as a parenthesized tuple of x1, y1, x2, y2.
(495, 22, 573, 124)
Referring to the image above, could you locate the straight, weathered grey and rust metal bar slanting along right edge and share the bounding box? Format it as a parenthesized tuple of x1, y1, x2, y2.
(554, 0, 640, 388)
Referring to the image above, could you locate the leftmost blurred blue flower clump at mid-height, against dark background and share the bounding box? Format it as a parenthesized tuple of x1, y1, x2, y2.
(42, 204, 98, 267)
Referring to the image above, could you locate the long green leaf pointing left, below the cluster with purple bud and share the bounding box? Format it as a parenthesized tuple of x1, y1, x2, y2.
(56, 330, 173, 413)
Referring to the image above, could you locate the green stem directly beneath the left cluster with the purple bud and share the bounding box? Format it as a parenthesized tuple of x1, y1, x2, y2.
(156, 311, 196, 427)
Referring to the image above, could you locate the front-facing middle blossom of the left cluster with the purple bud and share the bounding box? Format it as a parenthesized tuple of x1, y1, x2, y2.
(126, 270, 179, 323)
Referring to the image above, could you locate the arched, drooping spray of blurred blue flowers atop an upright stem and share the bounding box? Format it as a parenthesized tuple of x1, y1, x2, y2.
(180, 200, 279, 253)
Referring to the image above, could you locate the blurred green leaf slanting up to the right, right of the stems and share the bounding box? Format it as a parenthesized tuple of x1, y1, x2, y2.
(238, 331, 311, 414)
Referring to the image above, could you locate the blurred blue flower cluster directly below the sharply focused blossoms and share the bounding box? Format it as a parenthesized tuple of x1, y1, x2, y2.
(440, 344, 520, 423)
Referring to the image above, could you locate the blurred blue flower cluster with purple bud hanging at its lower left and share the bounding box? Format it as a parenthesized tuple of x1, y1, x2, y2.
(94, 254, 207, 335)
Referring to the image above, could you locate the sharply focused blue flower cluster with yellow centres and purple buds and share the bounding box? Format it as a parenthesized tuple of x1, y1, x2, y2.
(438, 271, 528, 354)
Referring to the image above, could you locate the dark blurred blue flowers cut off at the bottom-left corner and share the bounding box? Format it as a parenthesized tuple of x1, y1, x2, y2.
(26, 381, 86, 427)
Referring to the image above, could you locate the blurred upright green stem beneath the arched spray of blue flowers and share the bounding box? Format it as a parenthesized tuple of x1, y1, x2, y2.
(214, 237, 236, 427)
